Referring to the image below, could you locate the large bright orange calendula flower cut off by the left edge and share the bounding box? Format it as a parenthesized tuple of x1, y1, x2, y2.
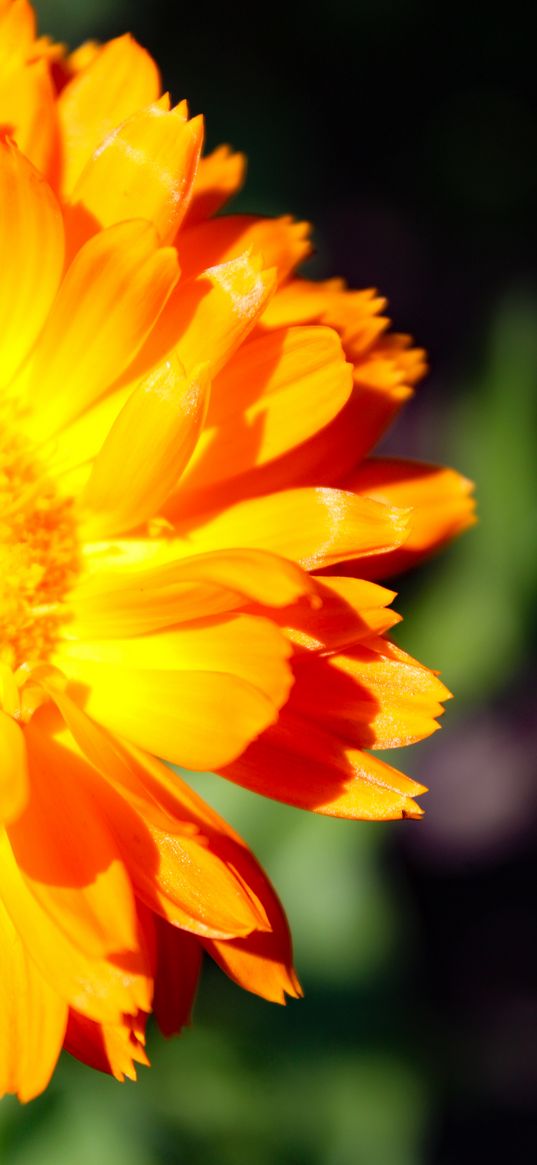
(0, 0, 472, 1100)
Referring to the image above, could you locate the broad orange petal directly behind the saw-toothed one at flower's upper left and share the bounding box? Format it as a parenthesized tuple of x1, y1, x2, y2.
(58, 36, 160, 193)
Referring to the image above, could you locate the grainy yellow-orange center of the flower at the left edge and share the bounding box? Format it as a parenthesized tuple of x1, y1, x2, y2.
(0, 424, 78, 670)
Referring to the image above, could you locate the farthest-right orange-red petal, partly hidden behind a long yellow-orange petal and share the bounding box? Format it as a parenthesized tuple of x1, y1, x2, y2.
(340, 458, 475, 578)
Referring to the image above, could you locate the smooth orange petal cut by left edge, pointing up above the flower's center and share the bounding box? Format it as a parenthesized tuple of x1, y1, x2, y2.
(0, 139, 64, 384)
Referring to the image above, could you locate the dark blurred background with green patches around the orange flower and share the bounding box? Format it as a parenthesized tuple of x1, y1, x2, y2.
(0, 0, 537, 1165)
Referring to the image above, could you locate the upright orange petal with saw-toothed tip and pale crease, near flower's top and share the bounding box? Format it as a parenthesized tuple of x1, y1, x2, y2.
(71, 99, 203, 245)
